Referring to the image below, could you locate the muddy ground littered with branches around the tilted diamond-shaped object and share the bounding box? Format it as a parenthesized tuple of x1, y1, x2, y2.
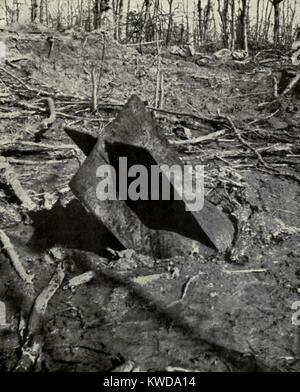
(0, 34, 300, 371)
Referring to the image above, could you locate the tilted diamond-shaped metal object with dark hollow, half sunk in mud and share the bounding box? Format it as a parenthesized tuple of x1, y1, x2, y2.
(70, 96, 234, 258)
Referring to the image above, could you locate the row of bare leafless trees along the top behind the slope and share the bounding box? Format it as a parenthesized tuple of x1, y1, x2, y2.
(4, 0, 297, 52)
